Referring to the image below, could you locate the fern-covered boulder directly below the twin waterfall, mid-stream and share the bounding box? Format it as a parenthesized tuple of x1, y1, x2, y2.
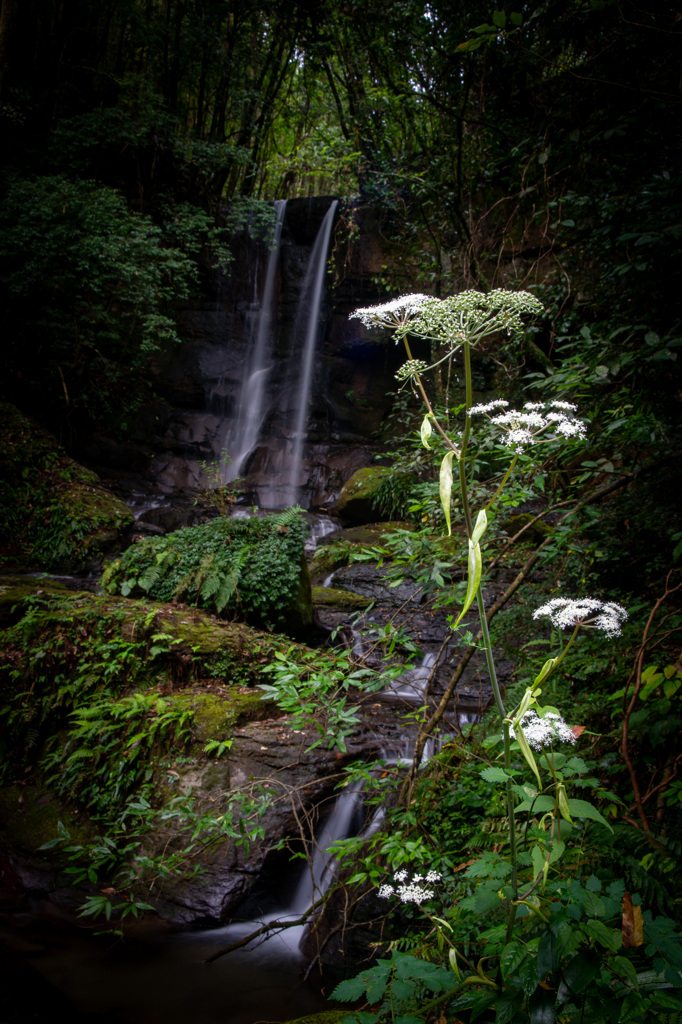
(102, 512, 312, 634)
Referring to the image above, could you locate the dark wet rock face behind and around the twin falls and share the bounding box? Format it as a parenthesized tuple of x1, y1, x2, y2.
(116, 197, 401, 508)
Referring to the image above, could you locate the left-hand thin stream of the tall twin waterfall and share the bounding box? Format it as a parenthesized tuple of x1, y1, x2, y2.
(224, 199, 287, 482)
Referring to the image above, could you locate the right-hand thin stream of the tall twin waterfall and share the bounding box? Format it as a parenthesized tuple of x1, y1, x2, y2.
(283, 200, 339, 506)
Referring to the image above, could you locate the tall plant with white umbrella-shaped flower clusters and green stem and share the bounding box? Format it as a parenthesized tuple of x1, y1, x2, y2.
(327, 290, 679, 1024)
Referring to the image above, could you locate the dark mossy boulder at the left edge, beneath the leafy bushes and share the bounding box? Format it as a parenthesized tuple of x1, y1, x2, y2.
(0, 402, 134, 572)
